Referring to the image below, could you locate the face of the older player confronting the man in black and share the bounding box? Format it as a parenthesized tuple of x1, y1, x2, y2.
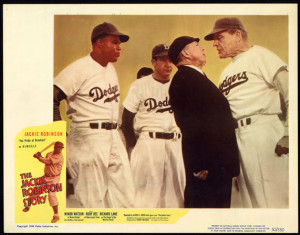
(213, 31, 240, 59)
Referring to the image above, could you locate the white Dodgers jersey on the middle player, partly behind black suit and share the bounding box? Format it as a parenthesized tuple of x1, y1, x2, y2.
(123, 74, 179, 133)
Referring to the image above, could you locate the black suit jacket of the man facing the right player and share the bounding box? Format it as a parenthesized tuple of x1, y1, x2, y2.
(169, 66, 240, 207)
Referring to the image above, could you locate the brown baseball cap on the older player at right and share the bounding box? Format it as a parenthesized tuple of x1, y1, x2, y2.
(204, 17, 246, 41)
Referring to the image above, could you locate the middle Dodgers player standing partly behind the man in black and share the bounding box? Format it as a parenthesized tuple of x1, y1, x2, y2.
(122, 44, 185, 208)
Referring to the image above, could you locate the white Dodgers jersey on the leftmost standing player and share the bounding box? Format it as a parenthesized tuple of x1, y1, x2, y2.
(54, 55, 120, 122)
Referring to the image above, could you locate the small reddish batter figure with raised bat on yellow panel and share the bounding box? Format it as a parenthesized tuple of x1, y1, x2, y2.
(23, 141, 64, 223)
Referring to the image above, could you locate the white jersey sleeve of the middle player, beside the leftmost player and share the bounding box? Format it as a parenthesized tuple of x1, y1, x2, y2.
(123, 80, 141, 113)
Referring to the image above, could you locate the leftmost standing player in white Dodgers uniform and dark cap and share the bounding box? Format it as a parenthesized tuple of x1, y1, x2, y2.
(54, 22, 134, 208)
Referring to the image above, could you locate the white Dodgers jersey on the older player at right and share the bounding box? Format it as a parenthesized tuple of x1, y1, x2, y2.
(219, 46, 287, 119)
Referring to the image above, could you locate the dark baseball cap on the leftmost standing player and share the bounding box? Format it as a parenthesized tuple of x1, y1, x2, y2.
(91, 22, 129, 43)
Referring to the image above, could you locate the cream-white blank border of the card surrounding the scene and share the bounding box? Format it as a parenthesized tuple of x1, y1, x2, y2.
(3, 4, 298, 232)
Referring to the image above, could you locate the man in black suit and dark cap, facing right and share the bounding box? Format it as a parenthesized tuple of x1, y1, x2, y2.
(169, 36, 239, 208)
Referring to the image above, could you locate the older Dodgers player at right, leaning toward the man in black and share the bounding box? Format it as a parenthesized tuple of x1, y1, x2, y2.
(205, 18, 289, 208)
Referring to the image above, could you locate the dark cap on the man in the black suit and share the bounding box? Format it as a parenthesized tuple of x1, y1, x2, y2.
(169, 36, 200, 64)
